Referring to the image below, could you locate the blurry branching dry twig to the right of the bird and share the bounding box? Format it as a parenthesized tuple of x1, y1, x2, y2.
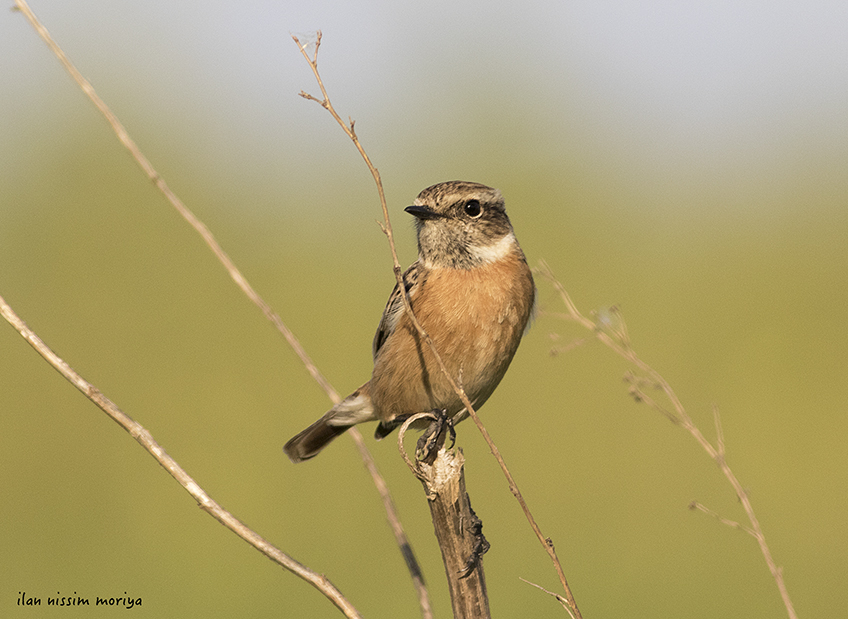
(536, 261, 797, 619)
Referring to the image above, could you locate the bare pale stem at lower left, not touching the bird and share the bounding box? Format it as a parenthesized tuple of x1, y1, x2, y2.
(0, 296, 361, 618)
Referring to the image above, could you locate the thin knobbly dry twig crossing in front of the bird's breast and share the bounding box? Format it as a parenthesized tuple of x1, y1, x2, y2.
(292, 30, 582, 619)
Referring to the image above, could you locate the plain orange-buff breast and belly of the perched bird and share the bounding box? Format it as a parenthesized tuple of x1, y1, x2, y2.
(371, 250, 535, 421)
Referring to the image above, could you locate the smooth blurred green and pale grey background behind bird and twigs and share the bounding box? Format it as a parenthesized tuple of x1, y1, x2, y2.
(0, 0, 848, 619)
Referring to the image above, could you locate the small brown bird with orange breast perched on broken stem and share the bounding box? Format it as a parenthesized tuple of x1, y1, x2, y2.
(283, 181, 536, 462)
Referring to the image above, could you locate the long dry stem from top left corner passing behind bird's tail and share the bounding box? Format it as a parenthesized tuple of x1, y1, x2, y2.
(15, 0, 431, 619)
